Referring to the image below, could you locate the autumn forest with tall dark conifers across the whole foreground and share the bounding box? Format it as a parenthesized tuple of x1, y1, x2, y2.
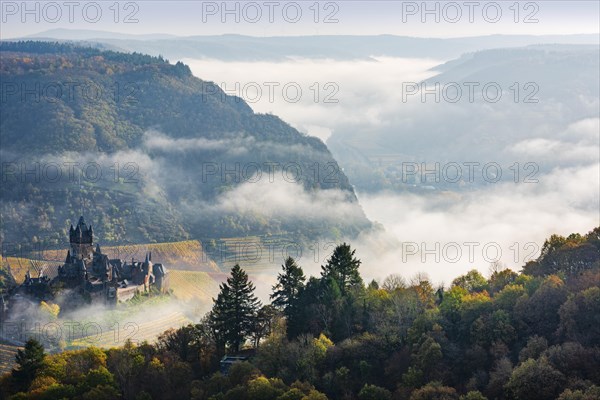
(1, 227, 600, 400)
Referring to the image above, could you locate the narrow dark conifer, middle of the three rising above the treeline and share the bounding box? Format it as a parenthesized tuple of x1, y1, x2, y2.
(270, 257, 306, 317)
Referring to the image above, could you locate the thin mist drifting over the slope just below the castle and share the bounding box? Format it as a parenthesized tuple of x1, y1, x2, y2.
(1, 291, 212, 350)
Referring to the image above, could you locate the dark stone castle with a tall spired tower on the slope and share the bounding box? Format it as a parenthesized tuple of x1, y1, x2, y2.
(19, 217, 169, 304)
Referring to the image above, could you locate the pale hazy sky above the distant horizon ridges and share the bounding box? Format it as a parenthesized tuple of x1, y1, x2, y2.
(0, 0, 600, 39)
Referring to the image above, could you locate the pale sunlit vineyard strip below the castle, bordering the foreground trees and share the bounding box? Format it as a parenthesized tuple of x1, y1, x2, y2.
(68, 312, 192, 348)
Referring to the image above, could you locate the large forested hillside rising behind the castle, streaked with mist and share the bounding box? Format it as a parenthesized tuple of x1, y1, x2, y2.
(0, 42, 371, 255)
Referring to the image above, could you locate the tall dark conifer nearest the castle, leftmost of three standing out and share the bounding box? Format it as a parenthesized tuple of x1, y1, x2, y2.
(210, 264, 260, 352)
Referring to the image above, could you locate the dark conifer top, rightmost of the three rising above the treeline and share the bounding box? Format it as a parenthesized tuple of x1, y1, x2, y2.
(321, 243, 363, 295)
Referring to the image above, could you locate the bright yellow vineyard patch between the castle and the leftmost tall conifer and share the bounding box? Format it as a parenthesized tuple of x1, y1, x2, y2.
(169, 270, 219, 302)
